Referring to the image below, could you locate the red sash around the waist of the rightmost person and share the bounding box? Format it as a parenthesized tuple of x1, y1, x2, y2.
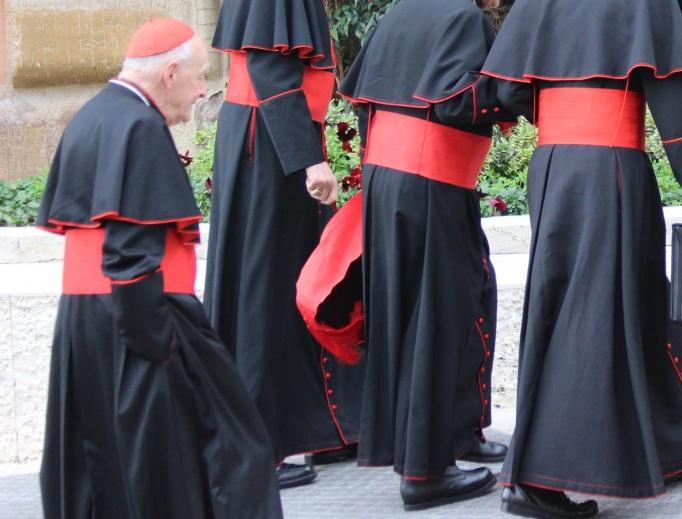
(538, 88, 646, 151)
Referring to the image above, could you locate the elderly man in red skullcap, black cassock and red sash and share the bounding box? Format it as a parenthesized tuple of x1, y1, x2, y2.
(38, 19, 281, 519)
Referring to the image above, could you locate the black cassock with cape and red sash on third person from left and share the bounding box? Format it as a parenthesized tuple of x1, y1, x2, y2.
(341, 0, 513, 479)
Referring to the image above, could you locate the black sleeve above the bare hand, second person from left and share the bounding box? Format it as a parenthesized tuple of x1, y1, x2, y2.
(246, 49, 325, 175)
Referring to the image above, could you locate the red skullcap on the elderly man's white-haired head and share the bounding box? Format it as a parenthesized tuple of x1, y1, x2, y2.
(126, 18, 195, 58)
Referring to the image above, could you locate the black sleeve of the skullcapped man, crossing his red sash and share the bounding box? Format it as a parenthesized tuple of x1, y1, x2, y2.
(102, 220, 176, 363)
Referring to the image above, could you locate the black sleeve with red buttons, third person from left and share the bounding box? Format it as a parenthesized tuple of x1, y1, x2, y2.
(432, 76, 516, 125)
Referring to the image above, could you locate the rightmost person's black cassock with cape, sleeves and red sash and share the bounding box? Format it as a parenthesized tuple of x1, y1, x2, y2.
(484, 0, 682, 498)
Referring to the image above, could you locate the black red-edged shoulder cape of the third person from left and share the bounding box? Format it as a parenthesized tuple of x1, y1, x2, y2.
(340, 0, 495, 108)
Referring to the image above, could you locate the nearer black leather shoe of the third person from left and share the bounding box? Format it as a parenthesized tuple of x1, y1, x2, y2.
(400, 467, 497, 512)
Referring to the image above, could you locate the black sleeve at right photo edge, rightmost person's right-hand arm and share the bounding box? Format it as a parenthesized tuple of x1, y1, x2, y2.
(640, 69, 682, 184)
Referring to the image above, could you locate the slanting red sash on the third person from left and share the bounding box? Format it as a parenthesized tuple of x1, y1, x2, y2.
(365, 110, 492, 189)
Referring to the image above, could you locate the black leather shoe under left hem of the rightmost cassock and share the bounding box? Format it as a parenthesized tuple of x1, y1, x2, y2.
(502, 485, 599, 519)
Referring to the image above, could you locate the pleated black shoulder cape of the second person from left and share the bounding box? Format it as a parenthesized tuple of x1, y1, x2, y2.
(212, 0, 335, 69)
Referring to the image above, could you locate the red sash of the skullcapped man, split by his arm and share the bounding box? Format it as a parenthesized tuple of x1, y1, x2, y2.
(62, 228, 197, 295)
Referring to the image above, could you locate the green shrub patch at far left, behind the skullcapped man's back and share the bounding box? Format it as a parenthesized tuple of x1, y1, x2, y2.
(0, 168, 47, 227)
